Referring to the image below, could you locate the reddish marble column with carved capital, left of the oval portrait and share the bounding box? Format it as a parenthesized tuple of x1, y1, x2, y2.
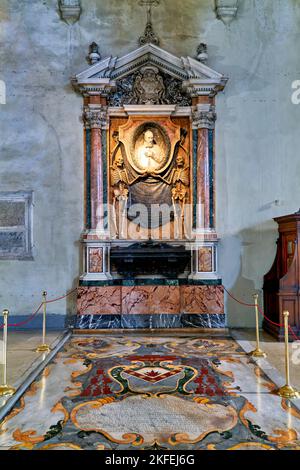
(84, 104, 107, 234)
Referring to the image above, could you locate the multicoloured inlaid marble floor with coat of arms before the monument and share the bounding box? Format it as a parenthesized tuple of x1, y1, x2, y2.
(0, 335, 300, 450)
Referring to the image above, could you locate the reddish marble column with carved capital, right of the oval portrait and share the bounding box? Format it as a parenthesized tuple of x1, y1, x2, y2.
(193, 103, 216, 234)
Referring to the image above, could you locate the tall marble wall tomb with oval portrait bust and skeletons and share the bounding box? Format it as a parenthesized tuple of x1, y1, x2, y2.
(73, 30, 226, 329)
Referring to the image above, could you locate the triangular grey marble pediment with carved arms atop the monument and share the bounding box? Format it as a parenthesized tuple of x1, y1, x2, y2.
(73, 44, 227, 101)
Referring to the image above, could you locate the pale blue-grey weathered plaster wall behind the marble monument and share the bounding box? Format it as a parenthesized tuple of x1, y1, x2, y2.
(0, 0, 300, 326)
